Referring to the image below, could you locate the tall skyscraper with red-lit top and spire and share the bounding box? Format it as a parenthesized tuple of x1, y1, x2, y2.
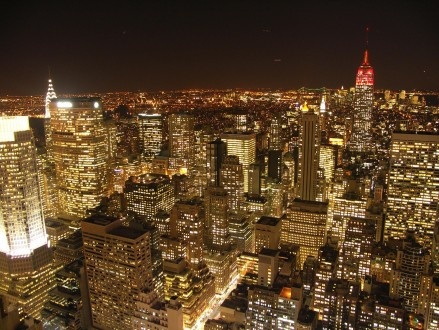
(349, 43, 374, 152)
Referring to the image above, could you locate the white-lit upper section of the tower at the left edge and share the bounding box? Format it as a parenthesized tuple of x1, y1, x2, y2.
(0, 116, 47, 257)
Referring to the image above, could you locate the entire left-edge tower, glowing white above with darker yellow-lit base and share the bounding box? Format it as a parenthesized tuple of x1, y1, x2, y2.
(0, 116, 53, 318)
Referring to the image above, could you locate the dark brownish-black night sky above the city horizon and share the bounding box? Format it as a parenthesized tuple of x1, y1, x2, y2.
(0, 0, 439, 95)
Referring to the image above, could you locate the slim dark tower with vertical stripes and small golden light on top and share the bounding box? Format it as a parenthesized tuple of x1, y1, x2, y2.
(298, 103, 320, 201)
